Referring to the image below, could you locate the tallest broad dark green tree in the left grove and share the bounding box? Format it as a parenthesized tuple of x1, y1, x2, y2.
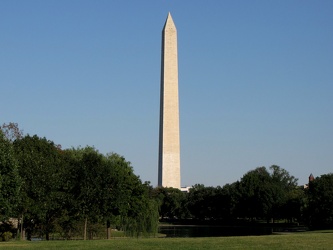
(13, 135, 66, 240)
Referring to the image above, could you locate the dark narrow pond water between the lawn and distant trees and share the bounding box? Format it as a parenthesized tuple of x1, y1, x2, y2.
(158, 225, 273, 238)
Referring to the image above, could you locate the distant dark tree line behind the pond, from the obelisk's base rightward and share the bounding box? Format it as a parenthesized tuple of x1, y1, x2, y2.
(153, 165, 333, 229)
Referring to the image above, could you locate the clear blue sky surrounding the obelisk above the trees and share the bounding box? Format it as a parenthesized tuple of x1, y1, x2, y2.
(0, 0, 333, 186)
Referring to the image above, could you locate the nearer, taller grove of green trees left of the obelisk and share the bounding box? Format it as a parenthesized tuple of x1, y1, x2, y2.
(0, 127, 158, 239)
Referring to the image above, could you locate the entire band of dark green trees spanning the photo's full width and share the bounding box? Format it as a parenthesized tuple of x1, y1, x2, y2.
(0, 123, 333, 240)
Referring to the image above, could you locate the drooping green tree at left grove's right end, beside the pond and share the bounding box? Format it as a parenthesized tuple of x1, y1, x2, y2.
(107, 154, 158, 236)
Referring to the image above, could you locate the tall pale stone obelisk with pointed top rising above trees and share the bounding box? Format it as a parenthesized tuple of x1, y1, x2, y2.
(158, 13, 180, 188)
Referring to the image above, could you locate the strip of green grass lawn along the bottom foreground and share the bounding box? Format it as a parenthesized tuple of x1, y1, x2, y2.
(0, 230, 333, 250)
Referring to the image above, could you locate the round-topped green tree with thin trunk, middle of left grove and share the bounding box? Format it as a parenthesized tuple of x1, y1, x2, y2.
(62, 146, 115, 240)
